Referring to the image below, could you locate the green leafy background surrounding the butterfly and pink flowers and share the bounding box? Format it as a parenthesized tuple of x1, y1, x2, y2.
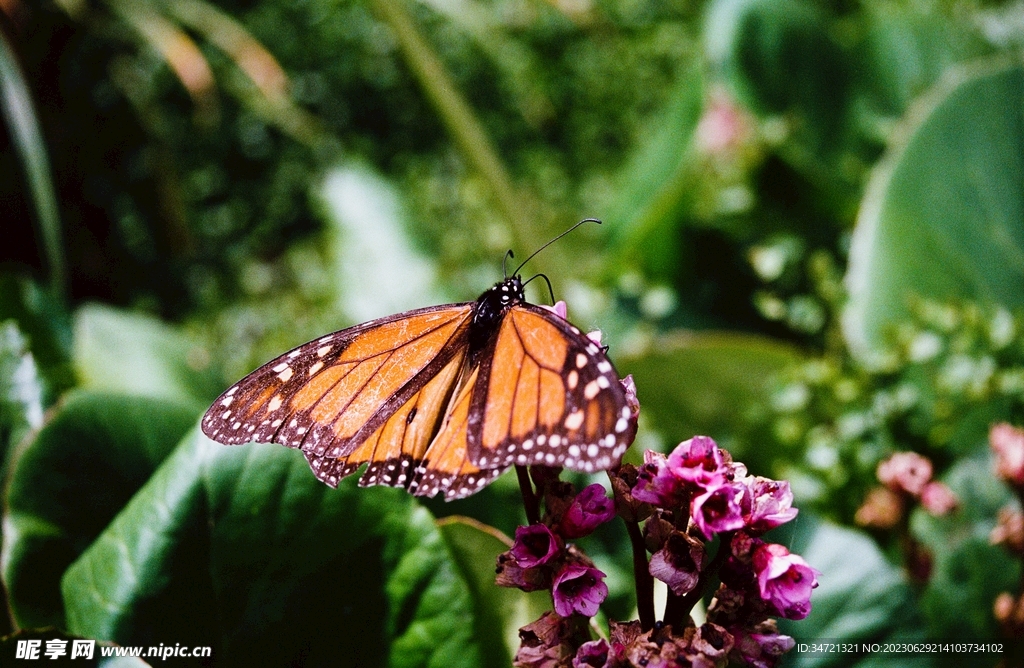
(0, 0, 1024, 666)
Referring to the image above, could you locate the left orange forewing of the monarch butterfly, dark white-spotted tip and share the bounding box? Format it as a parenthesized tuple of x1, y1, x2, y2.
(203, 303, 472, 457)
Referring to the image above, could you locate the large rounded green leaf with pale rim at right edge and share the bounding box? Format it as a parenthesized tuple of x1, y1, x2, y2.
(843, 62, 1024, 362)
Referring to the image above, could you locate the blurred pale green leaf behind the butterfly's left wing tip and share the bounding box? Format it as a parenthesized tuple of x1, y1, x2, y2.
(75, 304, 221, 408)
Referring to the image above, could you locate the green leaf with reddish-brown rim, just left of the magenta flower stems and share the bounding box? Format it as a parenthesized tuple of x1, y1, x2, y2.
(437, 516, 551, 666)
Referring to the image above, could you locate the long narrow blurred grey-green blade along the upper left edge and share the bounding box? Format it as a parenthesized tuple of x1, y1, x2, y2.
(0, 30, 68, 299)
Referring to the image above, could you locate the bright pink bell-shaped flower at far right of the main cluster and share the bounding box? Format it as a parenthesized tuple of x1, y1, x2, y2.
(754, 543, 821, 619)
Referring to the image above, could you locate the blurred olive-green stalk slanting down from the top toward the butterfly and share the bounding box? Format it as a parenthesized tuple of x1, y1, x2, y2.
(374, 0, 536, 247)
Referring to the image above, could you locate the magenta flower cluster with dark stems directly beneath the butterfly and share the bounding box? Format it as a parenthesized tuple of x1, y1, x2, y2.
(507, 436, 819, 668)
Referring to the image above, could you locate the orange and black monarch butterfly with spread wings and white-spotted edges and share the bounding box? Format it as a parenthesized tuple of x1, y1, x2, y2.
(202, 219, 632, 500)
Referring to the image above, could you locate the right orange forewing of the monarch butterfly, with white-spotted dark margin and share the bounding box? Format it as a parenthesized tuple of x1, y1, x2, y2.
(469, 303, 630, 471)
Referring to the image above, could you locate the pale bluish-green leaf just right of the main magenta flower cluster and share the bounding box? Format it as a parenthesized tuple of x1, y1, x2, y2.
(769, 513, 930, 666)
